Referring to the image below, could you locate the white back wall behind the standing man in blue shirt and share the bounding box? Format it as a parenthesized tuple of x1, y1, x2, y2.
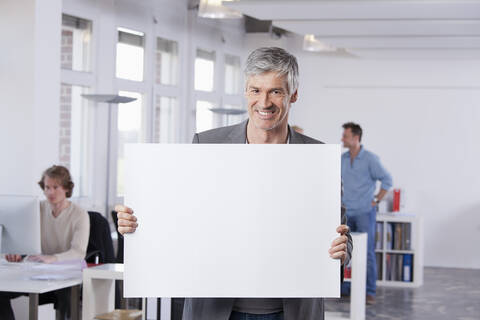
(249, 37, 480, 268)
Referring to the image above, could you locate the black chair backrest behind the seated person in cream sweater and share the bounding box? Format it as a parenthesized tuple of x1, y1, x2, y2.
(86, 211, 115, 263)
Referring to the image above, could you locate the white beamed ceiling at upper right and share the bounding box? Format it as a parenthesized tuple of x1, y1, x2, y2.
(223, 0, 480, 59)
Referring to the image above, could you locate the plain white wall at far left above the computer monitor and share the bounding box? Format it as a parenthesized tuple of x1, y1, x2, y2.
(0, 0, 61, 195)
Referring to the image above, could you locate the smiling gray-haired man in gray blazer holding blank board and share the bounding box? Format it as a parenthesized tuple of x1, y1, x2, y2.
(115, 48, 352, 320)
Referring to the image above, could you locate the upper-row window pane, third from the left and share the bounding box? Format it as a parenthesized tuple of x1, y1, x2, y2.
(155, 38, 178, 86)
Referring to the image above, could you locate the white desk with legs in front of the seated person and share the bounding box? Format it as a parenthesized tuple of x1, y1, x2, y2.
(0, 261, 82, 320)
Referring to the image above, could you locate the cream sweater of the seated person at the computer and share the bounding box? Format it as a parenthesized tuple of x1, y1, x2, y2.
(40, 201, 90, 261)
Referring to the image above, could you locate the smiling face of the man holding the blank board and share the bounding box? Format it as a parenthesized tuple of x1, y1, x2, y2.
(245, 72, 297, 130)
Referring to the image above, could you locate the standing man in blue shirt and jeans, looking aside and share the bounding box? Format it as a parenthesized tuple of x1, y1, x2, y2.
(342, 122, 392, 304)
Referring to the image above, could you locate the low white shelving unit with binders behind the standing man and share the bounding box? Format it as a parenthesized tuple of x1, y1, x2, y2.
(375, 212, 423, 287)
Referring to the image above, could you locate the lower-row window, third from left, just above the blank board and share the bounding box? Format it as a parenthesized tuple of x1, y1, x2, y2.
(154, 95, 177, 143)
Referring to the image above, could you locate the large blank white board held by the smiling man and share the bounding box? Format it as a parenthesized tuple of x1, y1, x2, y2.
(124, 144, 341, 297)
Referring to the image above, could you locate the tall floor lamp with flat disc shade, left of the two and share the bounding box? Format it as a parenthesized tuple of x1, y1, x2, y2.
(82, 94, 137, 218)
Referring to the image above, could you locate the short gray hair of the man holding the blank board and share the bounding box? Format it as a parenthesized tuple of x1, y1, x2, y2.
(245, 47, 298, 94)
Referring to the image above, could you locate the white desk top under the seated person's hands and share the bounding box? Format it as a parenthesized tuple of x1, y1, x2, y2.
(0, 260, 82, 293)
